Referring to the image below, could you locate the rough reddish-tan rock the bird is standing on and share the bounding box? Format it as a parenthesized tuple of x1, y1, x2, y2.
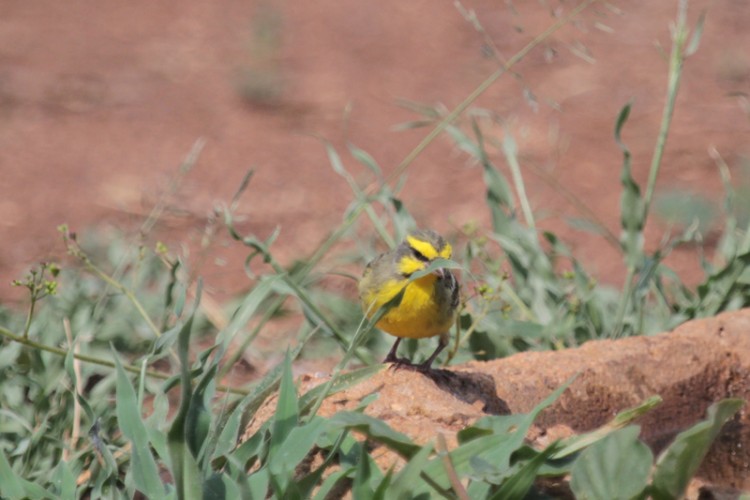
(245, 310, 750, 489)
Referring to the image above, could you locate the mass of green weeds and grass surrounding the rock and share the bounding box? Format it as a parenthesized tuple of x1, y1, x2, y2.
(0, 1, 750, 499)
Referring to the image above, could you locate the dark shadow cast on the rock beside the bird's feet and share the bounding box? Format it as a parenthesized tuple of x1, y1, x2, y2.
(421, 368, 511, 415)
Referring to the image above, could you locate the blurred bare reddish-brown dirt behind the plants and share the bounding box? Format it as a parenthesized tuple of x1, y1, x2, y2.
(0, 0, 750, 301)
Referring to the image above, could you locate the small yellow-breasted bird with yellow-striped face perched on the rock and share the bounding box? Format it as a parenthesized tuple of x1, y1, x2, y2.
(359, 230, 459, 371)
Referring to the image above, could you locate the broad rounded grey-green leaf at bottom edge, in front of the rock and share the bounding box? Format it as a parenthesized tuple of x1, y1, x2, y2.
(570, 425, 654, 500)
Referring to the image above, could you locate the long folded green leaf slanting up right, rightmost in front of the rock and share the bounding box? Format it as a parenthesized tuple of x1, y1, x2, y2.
(651, 399, 745, 500)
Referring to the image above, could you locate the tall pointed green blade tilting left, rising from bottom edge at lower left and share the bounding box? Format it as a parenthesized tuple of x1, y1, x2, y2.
(112, 347, 164, 498)
